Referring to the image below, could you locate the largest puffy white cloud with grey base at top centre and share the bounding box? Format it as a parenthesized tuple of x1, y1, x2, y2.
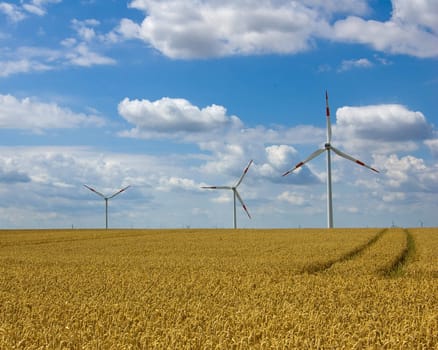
(118, 0, 330, 58)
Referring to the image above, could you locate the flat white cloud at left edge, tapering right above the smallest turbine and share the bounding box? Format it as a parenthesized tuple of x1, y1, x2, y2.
(0, 95, 105, 131)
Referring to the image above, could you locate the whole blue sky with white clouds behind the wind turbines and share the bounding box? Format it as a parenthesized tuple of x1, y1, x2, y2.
(0, 0, 438, 228)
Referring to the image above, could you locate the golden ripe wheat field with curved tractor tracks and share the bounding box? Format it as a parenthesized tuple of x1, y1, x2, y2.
(0, 228, 438, 349)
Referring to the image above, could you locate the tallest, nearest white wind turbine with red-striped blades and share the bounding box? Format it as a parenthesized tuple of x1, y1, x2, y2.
(283, 91, 379, 228)
